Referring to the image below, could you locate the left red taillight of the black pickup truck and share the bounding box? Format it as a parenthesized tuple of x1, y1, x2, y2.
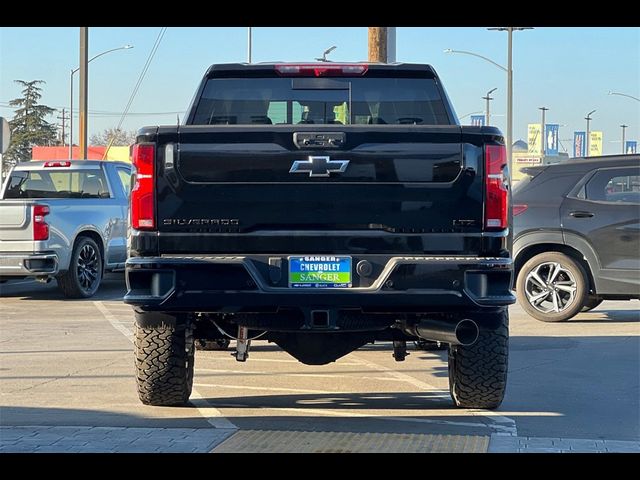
(131, 144, 156, 230)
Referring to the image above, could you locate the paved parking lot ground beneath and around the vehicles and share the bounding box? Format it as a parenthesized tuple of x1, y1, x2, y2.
(0, 274, 640, 452)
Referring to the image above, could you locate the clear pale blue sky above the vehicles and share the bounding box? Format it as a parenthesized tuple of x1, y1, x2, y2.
(0, 27, 640, 155)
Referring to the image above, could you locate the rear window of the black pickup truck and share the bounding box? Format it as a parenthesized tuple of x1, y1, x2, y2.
(191, 77, 451, 125)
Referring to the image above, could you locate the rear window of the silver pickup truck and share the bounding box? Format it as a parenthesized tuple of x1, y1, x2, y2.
(4, 169, 109, 199)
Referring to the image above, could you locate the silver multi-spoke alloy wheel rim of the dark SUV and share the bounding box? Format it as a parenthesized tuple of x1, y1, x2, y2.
(524, 262, 577, 313)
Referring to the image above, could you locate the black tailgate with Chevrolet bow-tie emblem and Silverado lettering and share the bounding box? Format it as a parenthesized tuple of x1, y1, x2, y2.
(156, 125, 483, 254)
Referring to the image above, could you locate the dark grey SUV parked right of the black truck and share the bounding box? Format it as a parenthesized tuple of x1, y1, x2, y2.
(513, 155, 640, 322)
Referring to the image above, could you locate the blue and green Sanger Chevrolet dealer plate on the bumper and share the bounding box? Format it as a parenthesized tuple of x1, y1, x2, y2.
(289, 255, 351, 288)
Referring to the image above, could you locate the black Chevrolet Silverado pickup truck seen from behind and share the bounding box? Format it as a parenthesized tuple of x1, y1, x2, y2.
(125, 63, 515, 408)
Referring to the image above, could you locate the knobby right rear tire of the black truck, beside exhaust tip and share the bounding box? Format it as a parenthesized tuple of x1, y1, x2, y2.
(449, 308, 509, 409)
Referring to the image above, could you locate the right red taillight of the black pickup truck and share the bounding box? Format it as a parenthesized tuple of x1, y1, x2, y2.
(484, 145, 509, 230)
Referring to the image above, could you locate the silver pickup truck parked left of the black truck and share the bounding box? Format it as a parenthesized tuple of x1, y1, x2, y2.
(0, 160, 131, 298)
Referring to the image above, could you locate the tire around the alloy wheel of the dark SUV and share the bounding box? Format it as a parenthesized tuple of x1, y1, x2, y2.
(516, 252, 589, 322)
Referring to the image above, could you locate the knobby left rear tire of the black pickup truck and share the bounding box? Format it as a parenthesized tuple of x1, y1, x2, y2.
(135, 324, 194, 406)
